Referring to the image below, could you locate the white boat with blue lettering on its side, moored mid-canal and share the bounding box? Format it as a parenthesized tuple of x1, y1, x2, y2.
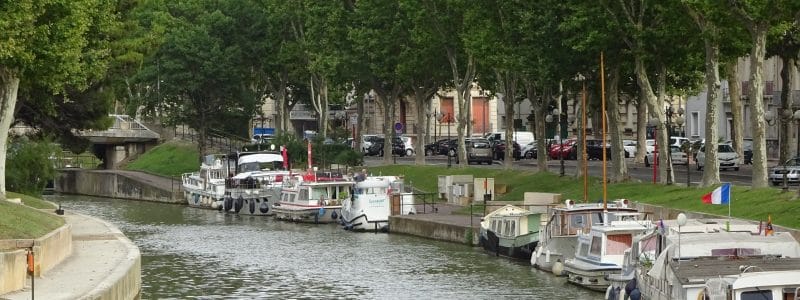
(340, 175, 416, 231)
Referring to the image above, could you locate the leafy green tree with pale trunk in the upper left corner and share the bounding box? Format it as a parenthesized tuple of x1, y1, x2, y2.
(0, 0, 115, 198)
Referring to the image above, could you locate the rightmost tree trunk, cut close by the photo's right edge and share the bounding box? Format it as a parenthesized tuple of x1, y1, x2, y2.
(776, 53, 796, 162)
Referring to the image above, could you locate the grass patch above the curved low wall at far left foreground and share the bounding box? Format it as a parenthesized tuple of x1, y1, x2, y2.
(0, 192, 64, 239)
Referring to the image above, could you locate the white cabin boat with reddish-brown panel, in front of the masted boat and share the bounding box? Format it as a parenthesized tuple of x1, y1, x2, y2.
(564, 220, 654, 291)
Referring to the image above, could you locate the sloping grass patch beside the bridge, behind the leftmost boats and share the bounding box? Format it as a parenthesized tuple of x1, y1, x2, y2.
(125, 141, 200, 177)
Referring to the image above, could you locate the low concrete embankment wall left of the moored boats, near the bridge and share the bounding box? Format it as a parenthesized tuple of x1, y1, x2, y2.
(54, 169, 184, 203)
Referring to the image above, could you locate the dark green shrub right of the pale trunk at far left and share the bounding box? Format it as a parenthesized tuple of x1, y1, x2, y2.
(6, 136, 58, 197)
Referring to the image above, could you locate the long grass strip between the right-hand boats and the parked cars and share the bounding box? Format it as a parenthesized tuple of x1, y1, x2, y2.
(368, 165, 800, 228)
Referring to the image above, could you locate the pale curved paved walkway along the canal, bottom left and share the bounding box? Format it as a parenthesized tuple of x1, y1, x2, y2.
(0, 211, 141, 300)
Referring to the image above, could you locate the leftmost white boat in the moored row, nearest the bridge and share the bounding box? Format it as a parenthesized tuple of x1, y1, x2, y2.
(181, 154, 229, 209)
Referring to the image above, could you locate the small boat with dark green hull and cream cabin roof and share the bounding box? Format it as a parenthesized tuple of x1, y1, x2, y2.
(478, 205, 542, 260)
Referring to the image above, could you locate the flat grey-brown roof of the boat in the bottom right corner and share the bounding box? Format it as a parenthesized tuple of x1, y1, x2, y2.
(672, 256, 800, 288)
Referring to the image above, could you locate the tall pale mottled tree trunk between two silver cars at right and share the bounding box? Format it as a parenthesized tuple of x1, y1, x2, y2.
(749, 24, 768, 188)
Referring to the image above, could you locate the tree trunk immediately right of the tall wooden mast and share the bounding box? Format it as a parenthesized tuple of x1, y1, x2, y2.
(606, 59, 630, 182)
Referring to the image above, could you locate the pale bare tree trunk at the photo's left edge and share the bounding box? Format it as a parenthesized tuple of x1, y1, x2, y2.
(0, 66, 19, 200)
